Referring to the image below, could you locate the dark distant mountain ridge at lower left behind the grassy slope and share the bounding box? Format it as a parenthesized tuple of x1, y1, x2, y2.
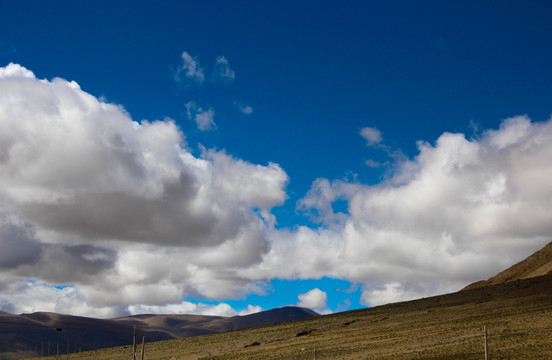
(0, 306, 318, 359)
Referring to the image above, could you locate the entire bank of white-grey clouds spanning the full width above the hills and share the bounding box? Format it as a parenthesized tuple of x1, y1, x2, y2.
(0, 63, 552, 317)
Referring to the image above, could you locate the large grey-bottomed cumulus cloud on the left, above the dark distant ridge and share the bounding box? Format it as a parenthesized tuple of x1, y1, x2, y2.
(0, 64, 288, 314)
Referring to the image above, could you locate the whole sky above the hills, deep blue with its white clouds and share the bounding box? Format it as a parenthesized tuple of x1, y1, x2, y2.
(0, 0, 552, 316)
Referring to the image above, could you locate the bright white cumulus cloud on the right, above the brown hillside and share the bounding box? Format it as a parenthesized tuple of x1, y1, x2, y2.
(244, 116, 552, 305)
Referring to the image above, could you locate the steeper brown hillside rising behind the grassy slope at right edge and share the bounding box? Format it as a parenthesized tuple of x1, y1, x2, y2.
(463, 242, 552, 290)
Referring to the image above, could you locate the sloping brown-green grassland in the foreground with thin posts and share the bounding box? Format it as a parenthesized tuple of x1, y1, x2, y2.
(24, 275, 552, 360)
